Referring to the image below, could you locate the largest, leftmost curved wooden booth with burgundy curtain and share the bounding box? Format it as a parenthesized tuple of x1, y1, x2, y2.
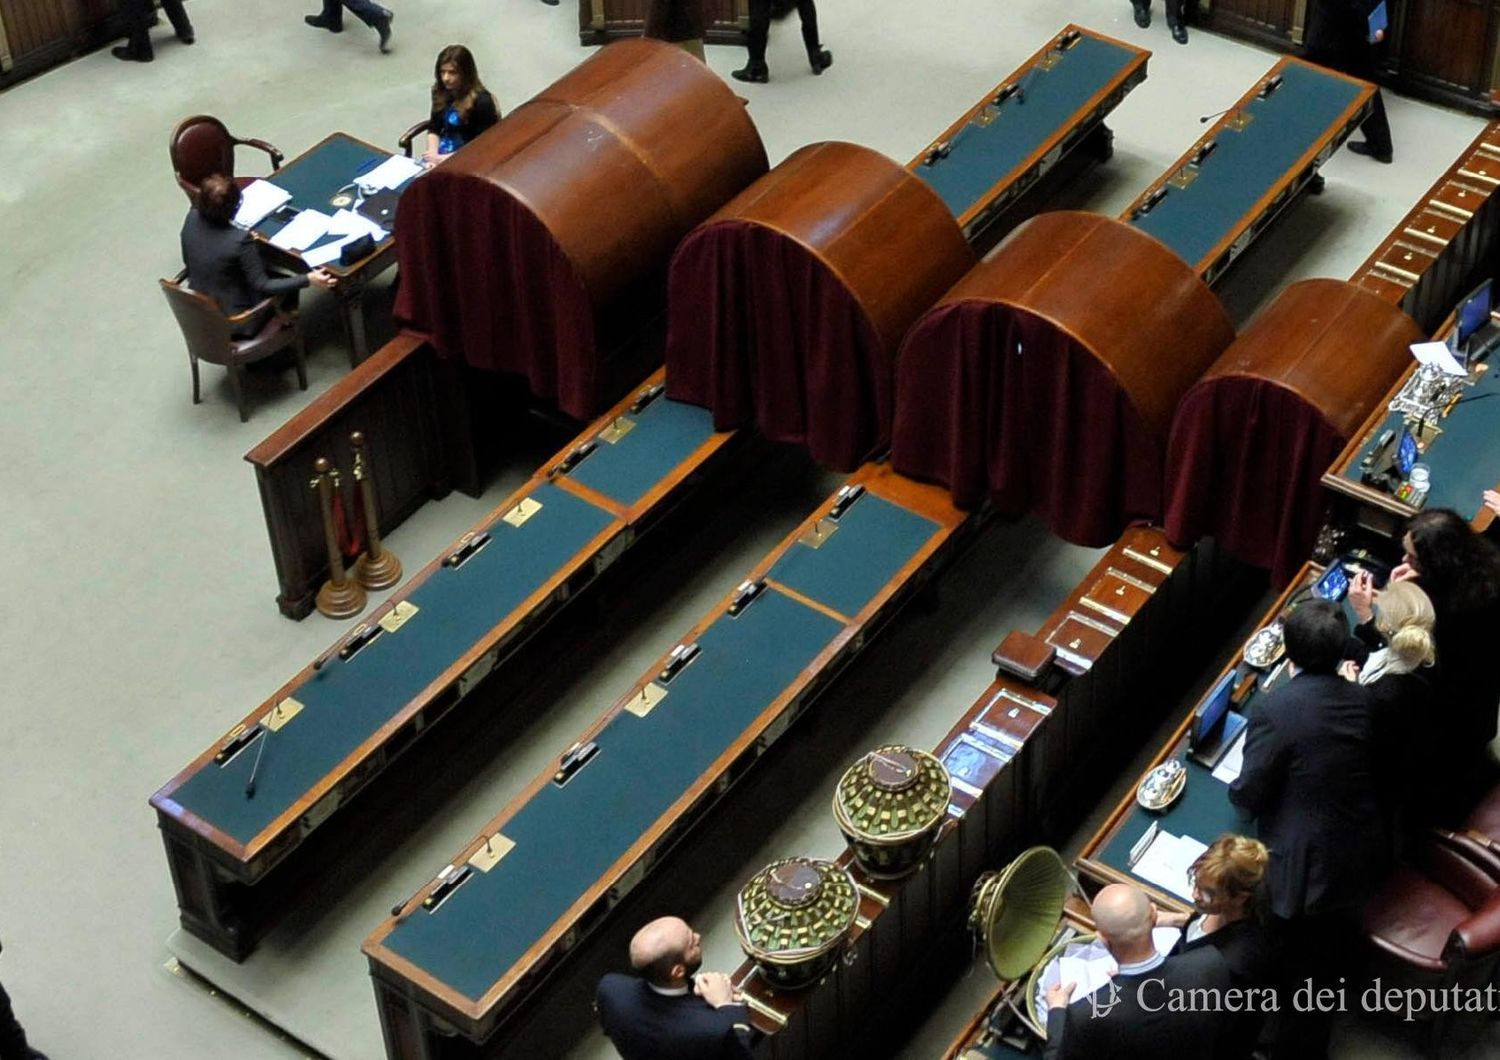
(396, 39, 767, 417)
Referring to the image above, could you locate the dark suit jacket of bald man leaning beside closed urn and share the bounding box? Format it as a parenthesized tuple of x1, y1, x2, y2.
(597, 972, 753, 1060)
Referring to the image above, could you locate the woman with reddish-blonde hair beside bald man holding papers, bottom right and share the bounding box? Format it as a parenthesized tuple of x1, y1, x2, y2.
(1157, 835, 1275, 1057)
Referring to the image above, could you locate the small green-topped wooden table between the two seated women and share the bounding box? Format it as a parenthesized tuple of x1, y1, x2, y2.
(251, 132, 410, 367)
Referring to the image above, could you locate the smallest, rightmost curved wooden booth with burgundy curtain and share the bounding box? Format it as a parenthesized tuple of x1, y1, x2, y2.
(1166, 279, 1425, 583)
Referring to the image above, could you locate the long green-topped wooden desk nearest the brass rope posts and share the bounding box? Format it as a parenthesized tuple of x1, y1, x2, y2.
(152, 372, 734, 960)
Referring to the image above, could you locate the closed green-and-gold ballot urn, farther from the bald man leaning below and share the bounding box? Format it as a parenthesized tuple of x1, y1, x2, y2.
(834, 744, 951, 880)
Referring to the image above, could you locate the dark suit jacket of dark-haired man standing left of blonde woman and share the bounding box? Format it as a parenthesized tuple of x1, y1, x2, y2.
(1229, 673, 1391, 919)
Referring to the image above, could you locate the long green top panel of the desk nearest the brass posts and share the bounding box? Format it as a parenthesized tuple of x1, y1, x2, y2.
(171, 486, 618, 843)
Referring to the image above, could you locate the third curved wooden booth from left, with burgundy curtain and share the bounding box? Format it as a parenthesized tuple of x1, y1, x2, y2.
(891, 211, 1235, 544)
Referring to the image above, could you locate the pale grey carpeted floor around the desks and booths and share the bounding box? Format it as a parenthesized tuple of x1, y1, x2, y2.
(0, 0, 1479, 1060)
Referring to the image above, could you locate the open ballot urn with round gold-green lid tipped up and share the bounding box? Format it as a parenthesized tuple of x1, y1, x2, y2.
(969, 847, 1092, 1038)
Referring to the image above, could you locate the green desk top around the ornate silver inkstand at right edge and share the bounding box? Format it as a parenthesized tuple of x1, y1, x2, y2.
(1340, 354, 1500, 519)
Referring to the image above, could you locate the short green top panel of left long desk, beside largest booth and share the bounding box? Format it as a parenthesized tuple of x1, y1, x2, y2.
(569, 394, 714, 507)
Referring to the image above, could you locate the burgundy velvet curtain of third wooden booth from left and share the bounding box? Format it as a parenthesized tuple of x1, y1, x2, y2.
(891, 300, 1164, 547)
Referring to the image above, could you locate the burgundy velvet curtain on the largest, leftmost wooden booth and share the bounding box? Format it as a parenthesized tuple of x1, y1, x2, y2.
(396, 166, 602, 418)
